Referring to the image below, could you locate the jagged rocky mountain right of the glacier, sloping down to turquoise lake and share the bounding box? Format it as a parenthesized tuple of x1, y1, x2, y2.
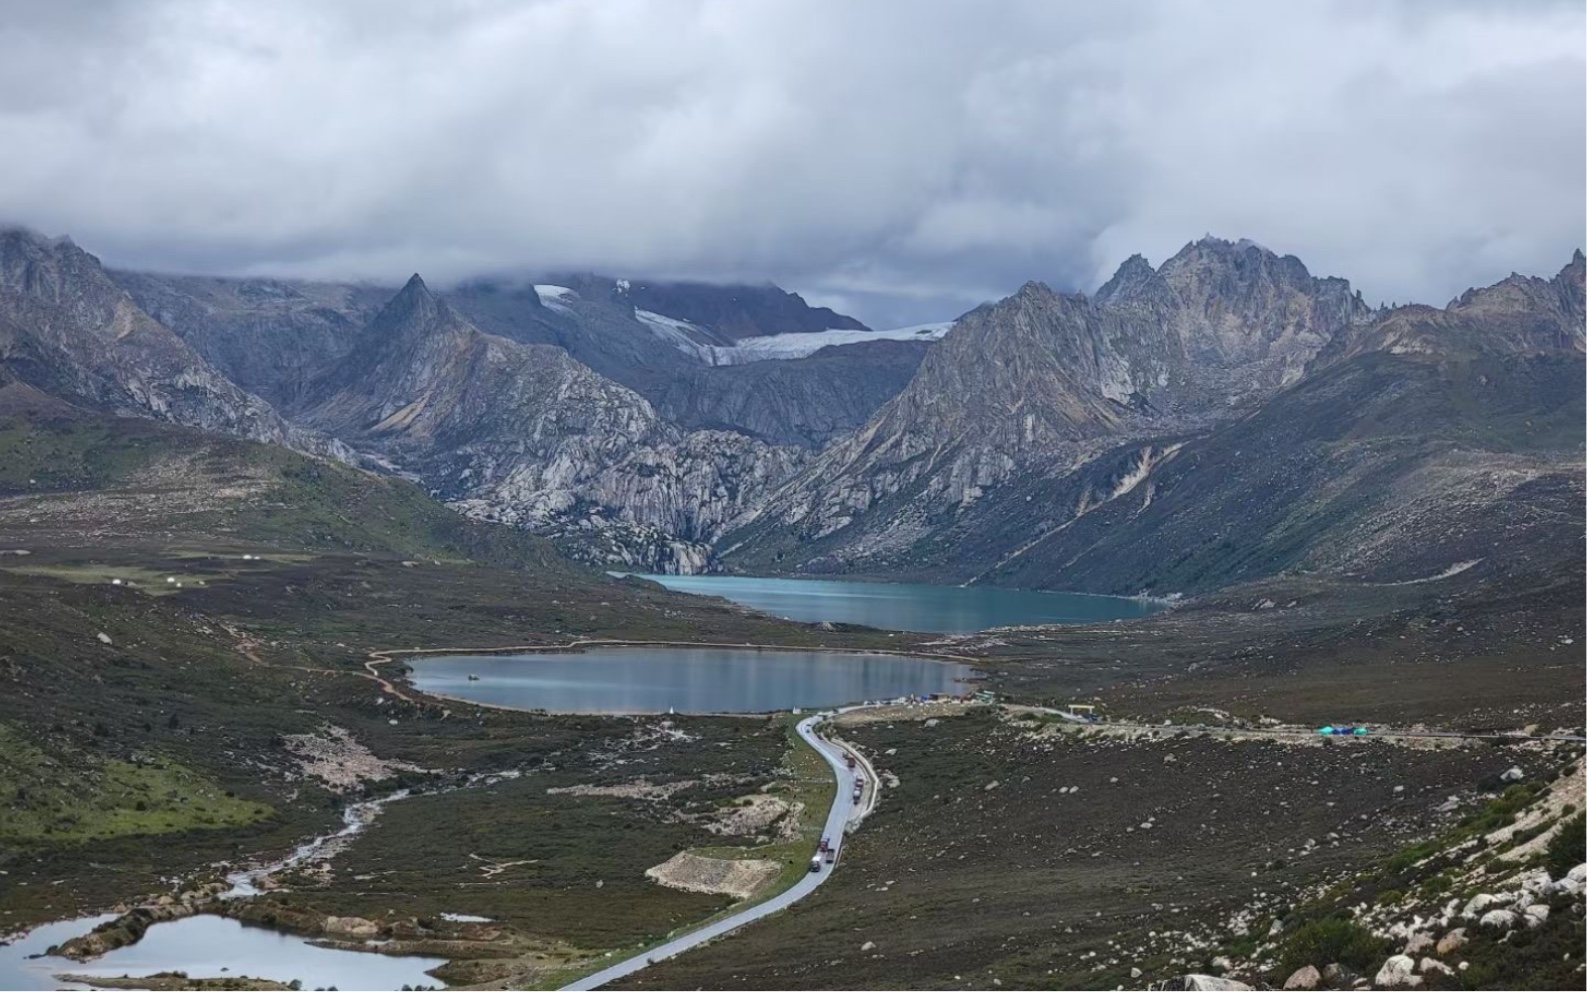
(724, 240, 1584, 593)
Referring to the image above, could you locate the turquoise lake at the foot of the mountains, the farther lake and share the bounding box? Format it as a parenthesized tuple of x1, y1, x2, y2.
(622, 576, 1162, 635)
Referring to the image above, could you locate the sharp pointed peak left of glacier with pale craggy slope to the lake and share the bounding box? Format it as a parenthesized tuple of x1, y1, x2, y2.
(300, 276, 798, 569)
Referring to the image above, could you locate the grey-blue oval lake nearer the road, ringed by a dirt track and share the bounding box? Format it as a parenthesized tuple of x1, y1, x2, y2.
(411, 646, 973, 714)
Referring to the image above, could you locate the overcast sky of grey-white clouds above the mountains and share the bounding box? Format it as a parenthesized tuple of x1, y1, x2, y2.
(0, 0, 1587, 325)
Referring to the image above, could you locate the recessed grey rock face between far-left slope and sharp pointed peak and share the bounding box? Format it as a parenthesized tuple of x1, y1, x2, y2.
(111, 271, 392, 406)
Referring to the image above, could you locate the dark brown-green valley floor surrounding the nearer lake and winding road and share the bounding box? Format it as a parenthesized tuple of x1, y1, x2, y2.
(0, 409, 1587, 988)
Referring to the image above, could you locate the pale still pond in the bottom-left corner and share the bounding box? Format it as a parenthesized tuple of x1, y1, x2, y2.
(0, 914, 446, 990)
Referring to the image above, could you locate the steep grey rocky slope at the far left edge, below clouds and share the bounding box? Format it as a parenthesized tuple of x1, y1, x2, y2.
(0, 228, 315, 452)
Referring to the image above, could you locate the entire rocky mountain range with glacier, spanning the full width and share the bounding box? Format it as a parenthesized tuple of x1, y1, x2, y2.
(0, 230, 1584, 595)
